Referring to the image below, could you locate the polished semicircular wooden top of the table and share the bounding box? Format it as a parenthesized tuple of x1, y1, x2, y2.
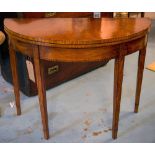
(4, 18, 151, 45)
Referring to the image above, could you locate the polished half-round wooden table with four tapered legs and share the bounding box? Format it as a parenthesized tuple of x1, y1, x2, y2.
(4, 18, 151, 139)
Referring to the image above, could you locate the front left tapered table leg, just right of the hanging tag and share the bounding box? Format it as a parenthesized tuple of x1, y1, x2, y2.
(33, 46, 49, 139)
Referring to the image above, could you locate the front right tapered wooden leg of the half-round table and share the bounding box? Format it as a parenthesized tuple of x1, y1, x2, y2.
(112, 56, 125, 139)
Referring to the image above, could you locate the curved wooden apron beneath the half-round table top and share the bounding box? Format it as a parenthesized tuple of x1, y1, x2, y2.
(10, 35, 147, 62)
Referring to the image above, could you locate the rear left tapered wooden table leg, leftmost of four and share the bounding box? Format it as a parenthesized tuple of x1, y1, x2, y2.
(9, 43, 21, 115)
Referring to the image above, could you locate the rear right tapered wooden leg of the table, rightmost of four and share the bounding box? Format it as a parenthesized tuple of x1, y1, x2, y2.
(134, 48, 146, 113)
